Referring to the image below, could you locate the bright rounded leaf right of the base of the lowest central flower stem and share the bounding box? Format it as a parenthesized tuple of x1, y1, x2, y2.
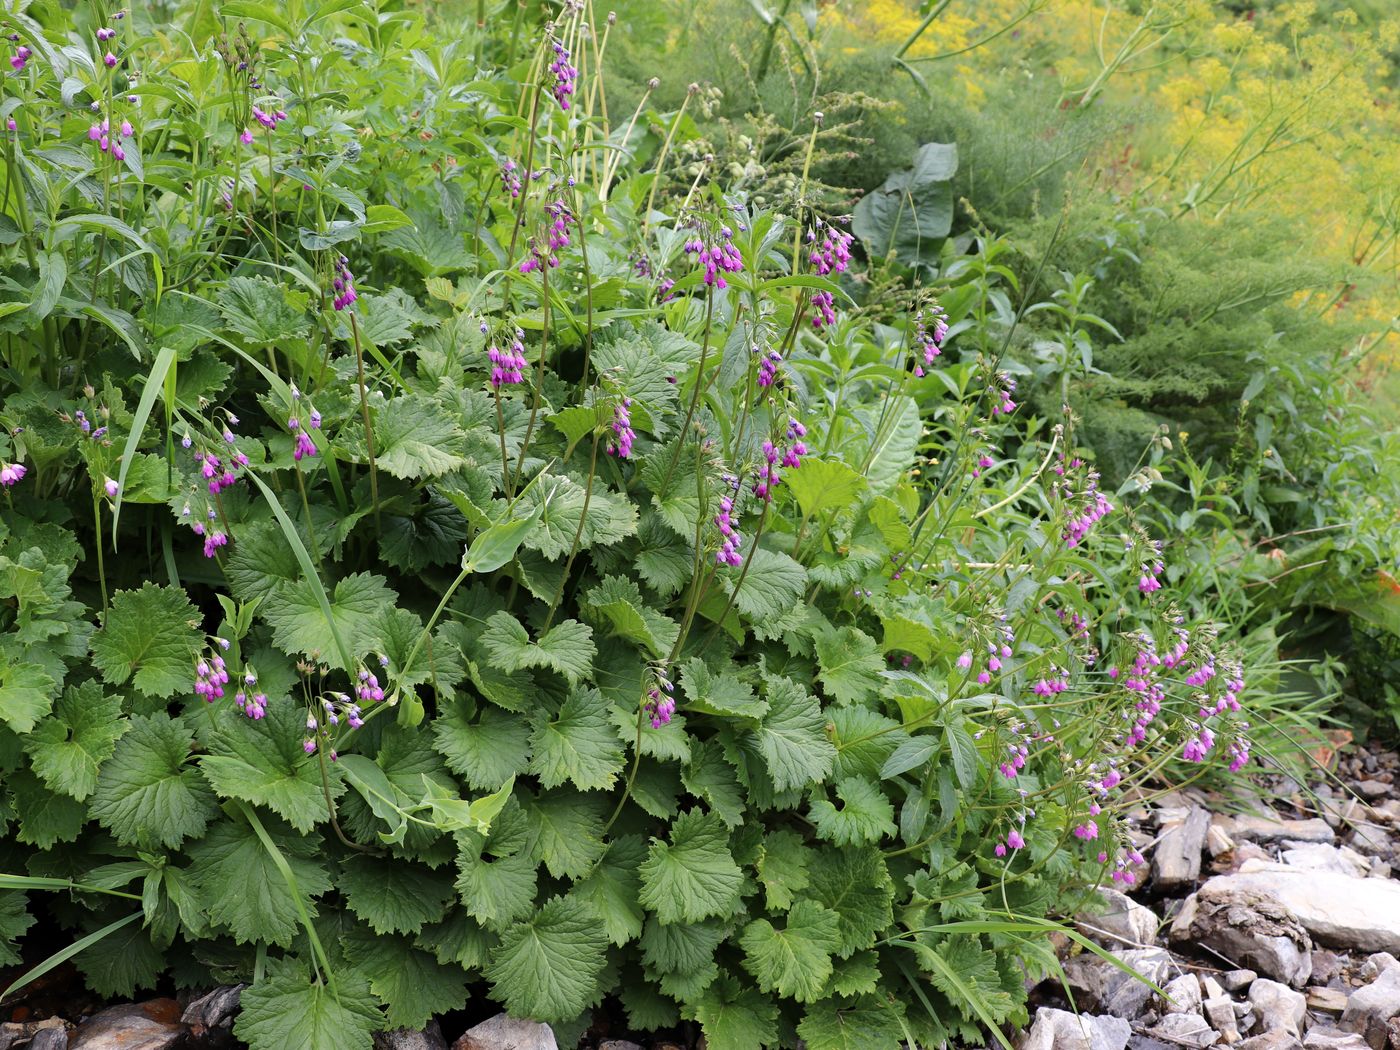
(638, 809, 743, 923)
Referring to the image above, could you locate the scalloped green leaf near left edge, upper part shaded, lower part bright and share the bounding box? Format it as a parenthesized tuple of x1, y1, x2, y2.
(22, 682, 129, 801)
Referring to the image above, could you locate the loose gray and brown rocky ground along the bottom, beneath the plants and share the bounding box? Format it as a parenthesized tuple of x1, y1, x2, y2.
(10, 749, 1400, 1050)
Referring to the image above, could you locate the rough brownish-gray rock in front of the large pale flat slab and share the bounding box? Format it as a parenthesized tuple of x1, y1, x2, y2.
(1172, 875, 1312, 987)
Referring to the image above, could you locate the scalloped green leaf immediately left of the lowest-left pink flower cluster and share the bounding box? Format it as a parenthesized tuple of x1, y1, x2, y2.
(91, 584, 202, 697)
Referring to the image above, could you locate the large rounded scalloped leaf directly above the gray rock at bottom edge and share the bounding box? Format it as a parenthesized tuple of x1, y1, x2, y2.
(486, 897, 608, 1022)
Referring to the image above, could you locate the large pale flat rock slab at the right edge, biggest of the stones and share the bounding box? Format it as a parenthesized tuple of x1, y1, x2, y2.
(1200, 861, 1400, 957)
